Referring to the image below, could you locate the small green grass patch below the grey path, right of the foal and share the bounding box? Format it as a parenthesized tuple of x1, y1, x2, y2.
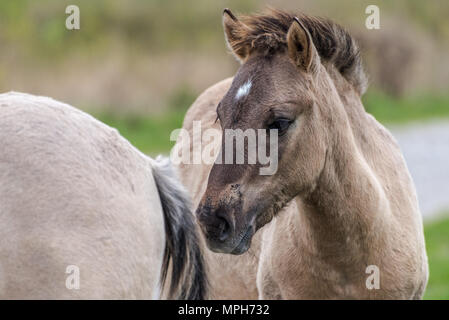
(424, 214, 449, 300)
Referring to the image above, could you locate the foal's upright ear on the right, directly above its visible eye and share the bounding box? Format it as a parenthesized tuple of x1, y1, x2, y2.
(287, 17, 320, 72)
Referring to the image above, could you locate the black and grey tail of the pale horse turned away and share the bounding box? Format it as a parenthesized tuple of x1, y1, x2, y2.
(153, 157, 207, 300)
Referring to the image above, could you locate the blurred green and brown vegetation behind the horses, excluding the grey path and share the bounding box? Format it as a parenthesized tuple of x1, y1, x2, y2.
(0, 0, 449, 299)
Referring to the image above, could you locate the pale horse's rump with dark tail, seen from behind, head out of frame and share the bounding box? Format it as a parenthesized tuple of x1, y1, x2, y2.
(0, 92, 207, 299)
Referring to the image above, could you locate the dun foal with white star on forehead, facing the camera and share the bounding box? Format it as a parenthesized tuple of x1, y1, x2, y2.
(175, 9, 428, 299)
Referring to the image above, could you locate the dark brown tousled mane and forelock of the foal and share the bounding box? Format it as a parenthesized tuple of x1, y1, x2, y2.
(232, 9, 367, 94)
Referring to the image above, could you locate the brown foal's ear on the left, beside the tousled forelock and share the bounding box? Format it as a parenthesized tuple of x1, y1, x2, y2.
(223, 9, 249, 63)
